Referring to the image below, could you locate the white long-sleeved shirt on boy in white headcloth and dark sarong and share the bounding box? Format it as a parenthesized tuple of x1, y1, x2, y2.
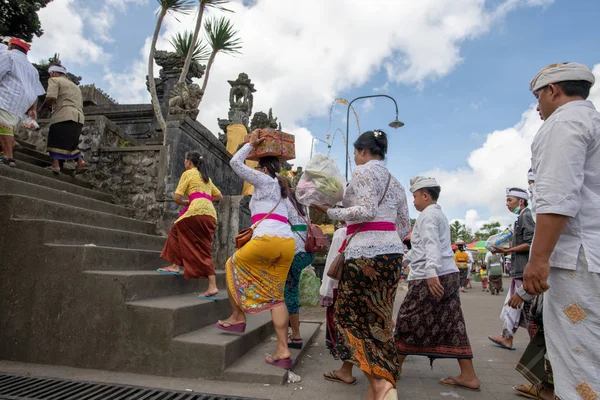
(405, 204, 458, 281)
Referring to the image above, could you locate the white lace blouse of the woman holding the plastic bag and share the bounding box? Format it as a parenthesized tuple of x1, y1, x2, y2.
(328, 160, 410, 258)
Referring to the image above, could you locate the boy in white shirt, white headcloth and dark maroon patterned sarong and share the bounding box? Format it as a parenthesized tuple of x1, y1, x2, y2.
(395, 176, 480, 391)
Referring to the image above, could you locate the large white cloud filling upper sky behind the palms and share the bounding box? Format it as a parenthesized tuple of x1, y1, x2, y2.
(107, 0, 553, 167)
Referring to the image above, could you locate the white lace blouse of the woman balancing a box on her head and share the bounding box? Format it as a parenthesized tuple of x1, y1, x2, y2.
(229, 143, 293, 239)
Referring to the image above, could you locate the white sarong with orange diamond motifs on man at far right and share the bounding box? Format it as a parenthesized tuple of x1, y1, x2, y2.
(544, 247, 600, 400)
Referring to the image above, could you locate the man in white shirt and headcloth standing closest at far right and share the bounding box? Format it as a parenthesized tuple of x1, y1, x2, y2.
(523, 63, 600, 400)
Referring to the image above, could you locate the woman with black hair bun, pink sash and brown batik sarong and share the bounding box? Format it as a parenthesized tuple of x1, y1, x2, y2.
(320, 131, 410, 400)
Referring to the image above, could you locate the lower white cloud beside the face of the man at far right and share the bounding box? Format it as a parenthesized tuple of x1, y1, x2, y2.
(436, 64, 600, 231)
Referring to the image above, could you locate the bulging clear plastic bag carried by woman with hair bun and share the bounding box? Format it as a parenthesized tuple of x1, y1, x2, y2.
(296, 154, 346, 206)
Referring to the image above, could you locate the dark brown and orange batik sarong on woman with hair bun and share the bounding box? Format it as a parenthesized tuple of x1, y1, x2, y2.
(334, 254, 402, 387)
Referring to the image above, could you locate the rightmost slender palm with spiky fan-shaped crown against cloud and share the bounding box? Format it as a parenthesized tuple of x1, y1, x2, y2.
(202, 17, 242, 106)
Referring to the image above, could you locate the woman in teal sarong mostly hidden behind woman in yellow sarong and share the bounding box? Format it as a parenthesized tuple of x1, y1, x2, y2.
(285, 189, 315, 349)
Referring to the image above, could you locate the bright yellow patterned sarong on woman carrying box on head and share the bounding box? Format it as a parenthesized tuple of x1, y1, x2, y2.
(225, 236, 296, 314)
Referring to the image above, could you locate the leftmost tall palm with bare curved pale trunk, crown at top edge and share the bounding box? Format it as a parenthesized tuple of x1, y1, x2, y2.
(148, 0, 193, 145)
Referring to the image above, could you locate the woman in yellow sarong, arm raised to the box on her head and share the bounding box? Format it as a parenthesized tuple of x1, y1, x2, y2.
(217, 133, 296, 369)
